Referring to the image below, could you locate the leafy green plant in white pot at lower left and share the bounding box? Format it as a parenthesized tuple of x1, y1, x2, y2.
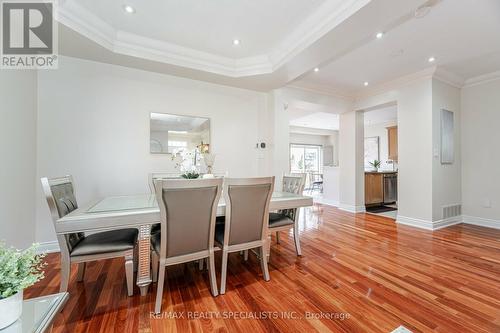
(0, 243, 45, 330)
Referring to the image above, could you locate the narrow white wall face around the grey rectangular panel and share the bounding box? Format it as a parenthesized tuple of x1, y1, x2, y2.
(432, 79, 462, 221)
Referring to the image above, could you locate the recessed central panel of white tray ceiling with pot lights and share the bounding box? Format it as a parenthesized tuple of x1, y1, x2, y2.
(74, 0, 324, 59)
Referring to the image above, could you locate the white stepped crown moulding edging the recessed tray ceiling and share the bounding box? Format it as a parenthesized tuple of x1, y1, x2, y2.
(58, 0, 371, 77)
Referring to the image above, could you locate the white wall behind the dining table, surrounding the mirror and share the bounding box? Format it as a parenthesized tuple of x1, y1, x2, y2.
(36, 57, 270, 241)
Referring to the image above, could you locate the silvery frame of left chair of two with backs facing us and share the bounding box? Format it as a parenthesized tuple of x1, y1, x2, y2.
(152, 178, 223, 313)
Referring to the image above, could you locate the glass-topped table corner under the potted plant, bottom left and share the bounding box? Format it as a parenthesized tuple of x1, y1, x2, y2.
(0, 293, 68, 333)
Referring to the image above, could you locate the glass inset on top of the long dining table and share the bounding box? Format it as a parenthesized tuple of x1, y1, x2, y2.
(87, 192, 304, 213)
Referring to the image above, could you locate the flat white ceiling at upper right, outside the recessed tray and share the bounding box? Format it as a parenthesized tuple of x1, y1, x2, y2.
(296, 0, 500, 95)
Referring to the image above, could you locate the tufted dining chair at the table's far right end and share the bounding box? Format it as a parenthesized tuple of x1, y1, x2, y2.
(269, 174, 305, 256)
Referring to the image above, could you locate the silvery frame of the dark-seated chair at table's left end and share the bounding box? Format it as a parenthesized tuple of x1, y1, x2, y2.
(41, 175, 134, 296)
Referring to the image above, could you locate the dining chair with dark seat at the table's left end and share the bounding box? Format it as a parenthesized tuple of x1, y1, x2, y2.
(41, 176, 138, 296)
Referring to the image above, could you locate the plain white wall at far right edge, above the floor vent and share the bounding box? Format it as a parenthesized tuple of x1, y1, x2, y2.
(461, 79, 500, 228)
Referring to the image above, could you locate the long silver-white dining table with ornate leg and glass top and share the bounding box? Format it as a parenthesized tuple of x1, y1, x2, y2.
(55, 191, 313, 296)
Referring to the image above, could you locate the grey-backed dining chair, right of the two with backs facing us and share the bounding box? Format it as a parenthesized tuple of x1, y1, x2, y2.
(215, 177, 274, 294)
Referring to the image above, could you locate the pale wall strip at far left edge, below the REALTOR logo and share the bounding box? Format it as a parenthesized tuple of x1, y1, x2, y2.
(0, 70, 36, 248)
